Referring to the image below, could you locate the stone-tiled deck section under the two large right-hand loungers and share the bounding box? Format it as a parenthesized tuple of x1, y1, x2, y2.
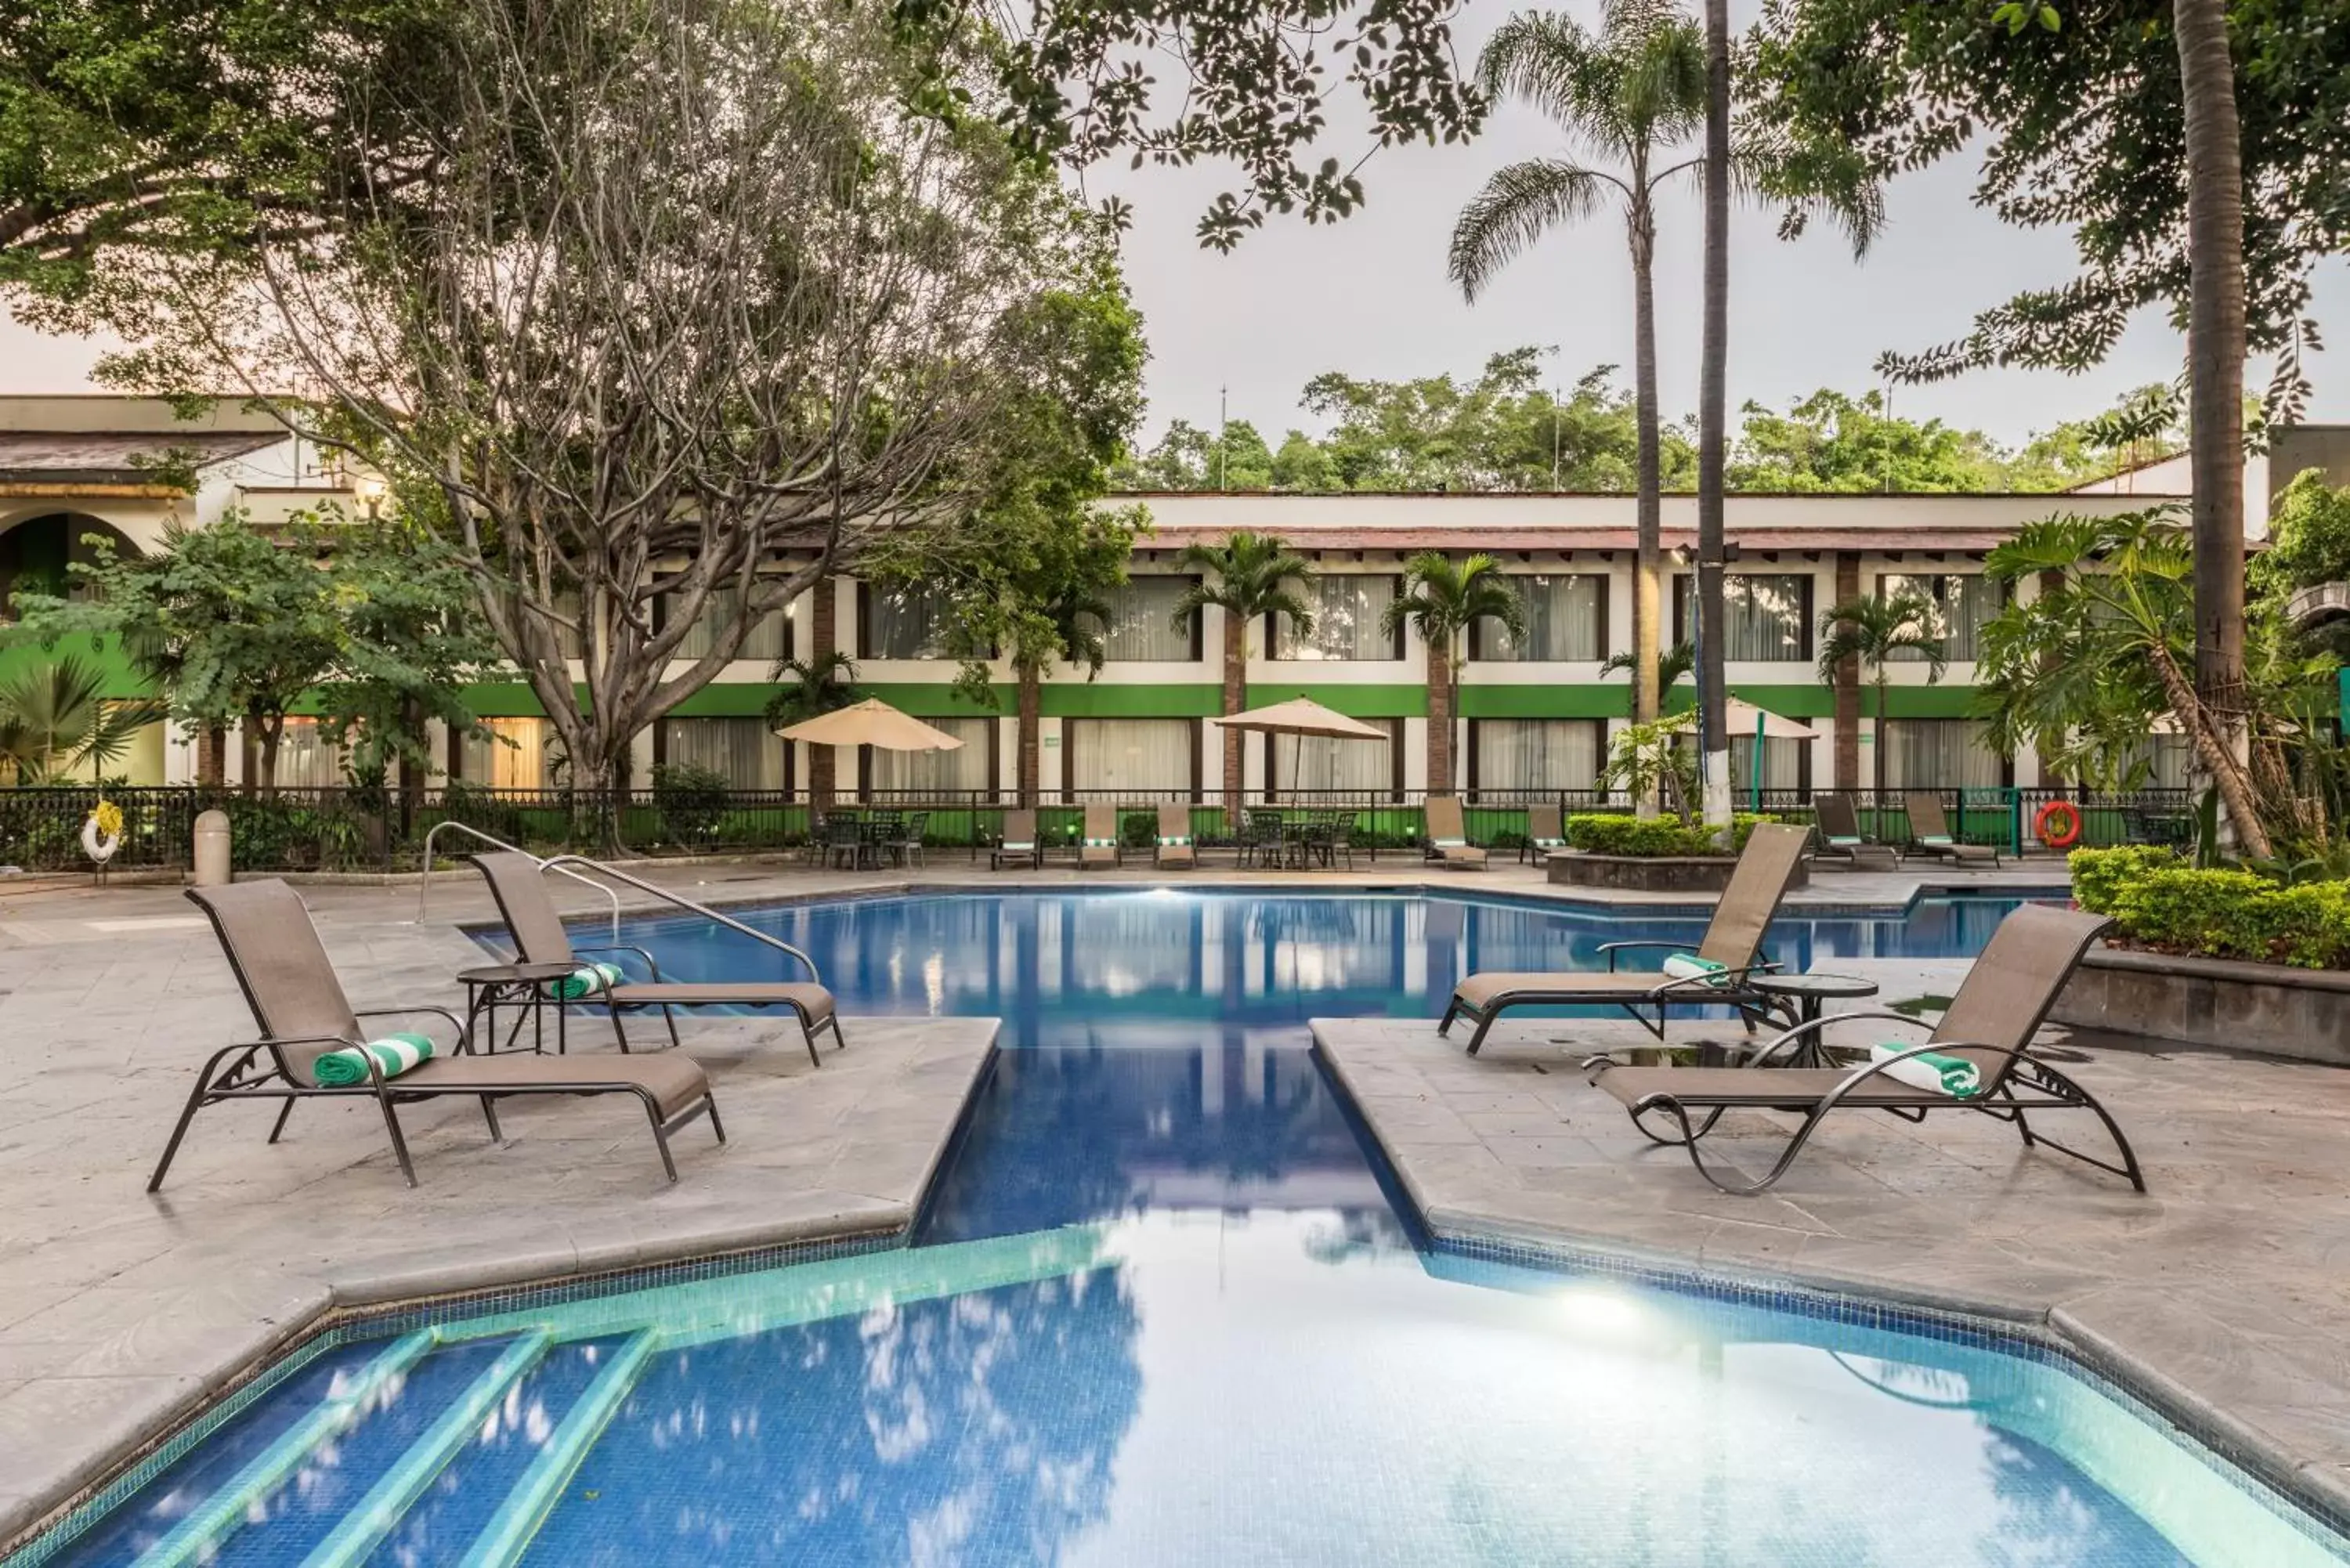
(1314, 959, 2350, 1516)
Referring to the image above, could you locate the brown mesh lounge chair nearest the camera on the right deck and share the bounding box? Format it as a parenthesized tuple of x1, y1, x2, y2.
(1584, 903, 2146, 1194)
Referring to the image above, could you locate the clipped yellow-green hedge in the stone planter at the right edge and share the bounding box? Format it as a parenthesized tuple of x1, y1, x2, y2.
(2070, 847, 2350, 969)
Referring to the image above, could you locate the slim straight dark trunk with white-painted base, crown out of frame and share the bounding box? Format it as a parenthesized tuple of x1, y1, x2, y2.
(1697, 0, 1730, 830)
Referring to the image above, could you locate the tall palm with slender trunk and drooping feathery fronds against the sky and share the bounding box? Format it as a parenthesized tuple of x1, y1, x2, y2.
(1452, 0, 1706, 747)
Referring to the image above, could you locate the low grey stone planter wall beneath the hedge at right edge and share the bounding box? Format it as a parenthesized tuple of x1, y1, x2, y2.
(2049, 948, 2350, 1068)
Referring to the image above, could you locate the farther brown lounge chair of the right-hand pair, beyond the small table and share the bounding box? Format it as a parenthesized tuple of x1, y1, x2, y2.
(1436, 823, 1812, 1056)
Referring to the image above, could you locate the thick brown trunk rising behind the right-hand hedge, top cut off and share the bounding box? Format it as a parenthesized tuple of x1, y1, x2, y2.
(2171, 0, 2256, 837)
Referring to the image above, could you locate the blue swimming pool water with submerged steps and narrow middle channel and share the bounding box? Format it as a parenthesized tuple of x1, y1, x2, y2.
(23, 891, 2350, 1568)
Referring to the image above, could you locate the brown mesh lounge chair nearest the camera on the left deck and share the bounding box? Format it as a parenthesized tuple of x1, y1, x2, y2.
(148, 880, 726, 1192)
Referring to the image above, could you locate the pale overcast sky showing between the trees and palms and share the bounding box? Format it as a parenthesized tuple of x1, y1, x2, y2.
(0, 0, 2350, 444)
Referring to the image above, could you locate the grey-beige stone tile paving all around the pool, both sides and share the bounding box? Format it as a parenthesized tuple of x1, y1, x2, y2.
(0, 851, 2350, 1542)
